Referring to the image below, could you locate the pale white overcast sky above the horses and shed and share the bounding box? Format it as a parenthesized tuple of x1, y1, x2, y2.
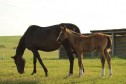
(0, 0, 126, 36)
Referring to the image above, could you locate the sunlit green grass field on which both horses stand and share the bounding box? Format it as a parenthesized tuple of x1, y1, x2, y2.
(0, 36, 126, 84)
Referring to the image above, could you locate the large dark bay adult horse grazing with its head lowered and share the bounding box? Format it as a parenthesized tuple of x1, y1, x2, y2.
(12, 23, 80, 76)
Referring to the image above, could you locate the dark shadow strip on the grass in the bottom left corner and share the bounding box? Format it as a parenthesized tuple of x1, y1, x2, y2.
(0, 80, 39, 84)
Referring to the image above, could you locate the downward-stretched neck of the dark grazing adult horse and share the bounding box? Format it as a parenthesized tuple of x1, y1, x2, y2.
(16, 37, 26, 56)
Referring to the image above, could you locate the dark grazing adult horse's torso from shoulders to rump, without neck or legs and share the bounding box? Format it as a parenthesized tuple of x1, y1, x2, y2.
(23, 23, 80, 51)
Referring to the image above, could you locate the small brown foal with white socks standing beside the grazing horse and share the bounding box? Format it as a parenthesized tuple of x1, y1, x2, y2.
(57, 26, 112, 77)
